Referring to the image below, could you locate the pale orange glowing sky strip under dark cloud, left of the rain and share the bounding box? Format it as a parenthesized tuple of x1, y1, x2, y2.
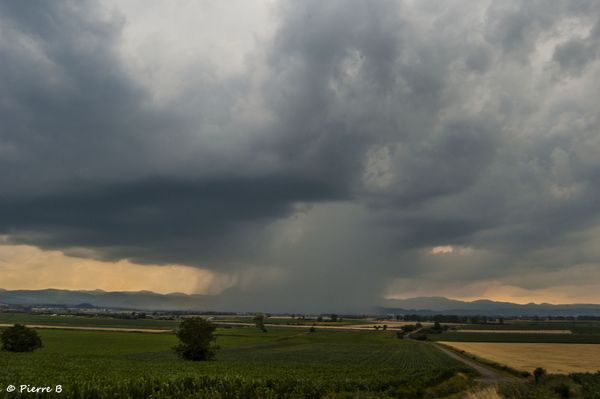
(0, 241, 232, 294)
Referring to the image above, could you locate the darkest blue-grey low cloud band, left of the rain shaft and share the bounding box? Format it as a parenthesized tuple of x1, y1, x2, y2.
(0, 176, 343, 266)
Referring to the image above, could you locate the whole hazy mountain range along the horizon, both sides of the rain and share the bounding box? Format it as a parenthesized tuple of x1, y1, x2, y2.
(0, 289, 600, 317)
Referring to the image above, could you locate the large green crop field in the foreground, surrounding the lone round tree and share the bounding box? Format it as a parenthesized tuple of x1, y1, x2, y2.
(0, 328, 471, 398)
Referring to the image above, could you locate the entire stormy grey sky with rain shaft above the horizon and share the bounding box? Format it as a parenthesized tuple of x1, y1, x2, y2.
(0, 0, 600, 310)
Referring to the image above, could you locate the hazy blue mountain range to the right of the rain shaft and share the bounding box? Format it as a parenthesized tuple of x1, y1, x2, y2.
(378, 297, 600, 316)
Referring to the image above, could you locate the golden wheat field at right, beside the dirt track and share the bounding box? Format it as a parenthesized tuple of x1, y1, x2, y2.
(441, 342, 600, 374)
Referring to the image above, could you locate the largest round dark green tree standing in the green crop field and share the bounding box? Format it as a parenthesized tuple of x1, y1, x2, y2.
(174, 317, 219, 360)
